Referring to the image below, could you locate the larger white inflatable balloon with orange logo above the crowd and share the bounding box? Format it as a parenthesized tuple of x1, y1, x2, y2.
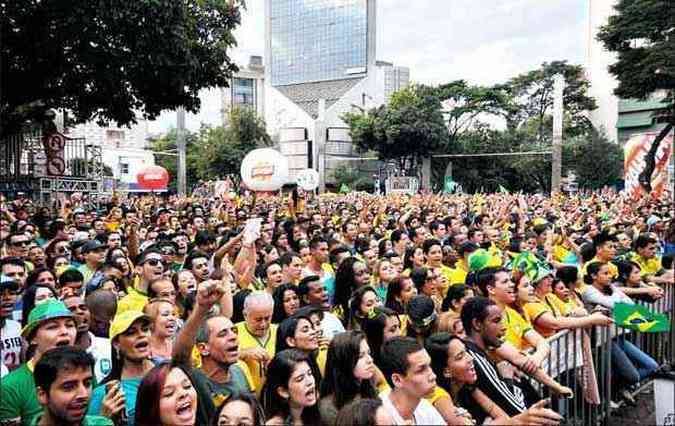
(241, 148, 288, 191)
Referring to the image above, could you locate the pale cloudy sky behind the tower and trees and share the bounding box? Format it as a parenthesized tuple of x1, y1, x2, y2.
(149, 0, 590, 133)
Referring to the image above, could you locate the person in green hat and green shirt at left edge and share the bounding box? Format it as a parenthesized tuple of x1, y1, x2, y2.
(0, 299, 77, 425)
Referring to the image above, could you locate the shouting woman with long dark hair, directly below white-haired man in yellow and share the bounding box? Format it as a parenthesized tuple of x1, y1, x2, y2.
(261, 349, 321, 425)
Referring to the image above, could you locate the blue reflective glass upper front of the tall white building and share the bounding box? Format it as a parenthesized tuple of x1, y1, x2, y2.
(269, 0, 368, 86)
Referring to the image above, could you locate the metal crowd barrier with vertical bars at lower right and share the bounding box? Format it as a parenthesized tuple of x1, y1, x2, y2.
(541, 284, 675, 426)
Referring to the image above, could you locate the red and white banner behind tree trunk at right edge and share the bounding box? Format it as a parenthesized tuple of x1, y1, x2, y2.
(623, 133, 673, 197)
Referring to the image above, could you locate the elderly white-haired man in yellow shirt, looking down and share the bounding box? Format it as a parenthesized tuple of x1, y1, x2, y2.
(236, 291, 277, 389)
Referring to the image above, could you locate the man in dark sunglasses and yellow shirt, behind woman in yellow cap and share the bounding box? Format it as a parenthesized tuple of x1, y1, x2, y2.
(117, 248, 165, 315)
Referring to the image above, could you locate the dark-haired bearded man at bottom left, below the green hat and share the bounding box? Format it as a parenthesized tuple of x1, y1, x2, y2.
(31, 346, 114, 426)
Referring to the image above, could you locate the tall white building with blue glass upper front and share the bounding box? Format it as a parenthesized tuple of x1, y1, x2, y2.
(265, 0, 410, 189)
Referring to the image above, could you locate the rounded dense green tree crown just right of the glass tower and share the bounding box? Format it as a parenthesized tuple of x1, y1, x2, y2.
(342, 85, 448, 172)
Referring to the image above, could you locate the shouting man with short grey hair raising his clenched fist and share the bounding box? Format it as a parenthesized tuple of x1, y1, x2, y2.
(173, 280, 255, 407)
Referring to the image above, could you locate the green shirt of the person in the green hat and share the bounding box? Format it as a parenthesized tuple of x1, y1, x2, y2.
(0, 363, 42, 425)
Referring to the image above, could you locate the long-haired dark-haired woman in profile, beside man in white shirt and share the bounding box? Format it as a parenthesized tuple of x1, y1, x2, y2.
(319, 331, 377, 424)
